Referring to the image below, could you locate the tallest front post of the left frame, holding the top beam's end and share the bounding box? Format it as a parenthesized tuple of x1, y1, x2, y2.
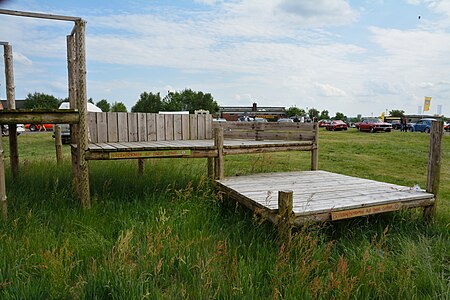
(75, 19, 91, 208)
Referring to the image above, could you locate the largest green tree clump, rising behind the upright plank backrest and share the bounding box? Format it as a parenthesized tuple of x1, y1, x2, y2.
(161, 89, 219, 114)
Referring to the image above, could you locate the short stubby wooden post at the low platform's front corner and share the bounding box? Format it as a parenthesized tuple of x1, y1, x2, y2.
(278, 191, 295, 246)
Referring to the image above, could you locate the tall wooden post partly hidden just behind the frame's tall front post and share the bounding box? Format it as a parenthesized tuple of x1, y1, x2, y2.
(67, 35, 81, 198)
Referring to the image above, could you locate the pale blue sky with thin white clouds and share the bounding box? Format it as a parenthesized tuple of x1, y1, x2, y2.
(0, 0, 450, 116)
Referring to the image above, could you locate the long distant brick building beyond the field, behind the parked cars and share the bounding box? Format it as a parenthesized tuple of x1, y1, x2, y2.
(219, 103, 286, 121)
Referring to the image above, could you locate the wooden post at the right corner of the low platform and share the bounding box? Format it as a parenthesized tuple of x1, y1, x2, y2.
(424, 121, 444, 220)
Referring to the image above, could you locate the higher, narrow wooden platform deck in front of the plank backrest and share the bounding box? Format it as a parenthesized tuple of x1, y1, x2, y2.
(83, 139, 313, 160)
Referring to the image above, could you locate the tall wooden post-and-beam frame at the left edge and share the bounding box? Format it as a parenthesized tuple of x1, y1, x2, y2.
(0, 9, 90, 218)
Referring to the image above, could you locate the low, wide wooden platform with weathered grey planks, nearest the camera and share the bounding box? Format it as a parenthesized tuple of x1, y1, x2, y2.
(216, 171, 434, 224)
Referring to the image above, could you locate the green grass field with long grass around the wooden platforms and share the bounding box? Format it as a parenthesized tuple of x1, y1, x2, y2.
(0, 130, 450, 299)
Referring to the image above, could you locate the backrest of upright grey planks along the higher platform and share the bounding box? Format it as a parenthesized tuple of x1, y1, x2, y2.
(89, 112, 212, 143)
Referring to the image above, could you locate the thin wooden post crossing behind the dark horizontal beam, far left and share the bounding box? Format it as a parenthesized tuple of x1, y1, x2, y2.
(3, 44, 19, 180)
